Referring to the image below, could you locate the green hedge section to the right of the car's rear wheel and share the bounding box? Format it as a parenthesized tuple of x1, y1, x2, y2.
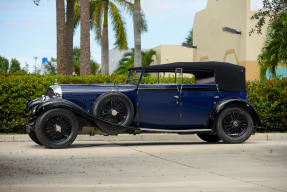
(247, 78, 287, 132)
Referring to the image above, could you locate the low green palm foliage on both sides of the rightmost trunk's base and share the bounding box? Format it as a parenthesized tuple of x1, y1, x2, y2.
(115, 49, 156, 74)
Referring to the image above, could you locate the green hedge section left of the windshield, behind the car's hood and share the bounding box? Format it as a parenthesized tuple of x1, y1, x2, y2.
(0, 74, 125, 133)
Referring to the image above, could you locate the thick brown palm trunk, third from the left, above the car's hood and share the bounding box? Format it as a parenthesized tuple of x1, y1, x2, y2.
(80, 0, 91, 75)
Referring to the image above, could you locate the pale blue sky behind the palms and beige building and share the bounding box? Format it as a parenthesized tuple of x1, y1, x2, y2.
(0, 0, 262, 70)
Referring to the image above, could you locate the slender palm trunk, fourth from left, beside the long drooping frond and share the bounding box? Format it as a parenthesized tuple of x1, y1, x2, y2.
(101, 0, 109, 74)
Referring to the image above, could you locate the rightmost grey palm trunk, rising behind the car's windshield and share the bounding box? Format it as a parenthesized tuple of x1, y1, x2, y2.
(133, 0, 147, 67)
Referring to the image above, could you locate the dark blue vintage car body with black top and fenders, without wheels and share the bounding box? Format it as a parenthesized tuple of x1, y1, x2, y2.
(27, 62, 261, 147)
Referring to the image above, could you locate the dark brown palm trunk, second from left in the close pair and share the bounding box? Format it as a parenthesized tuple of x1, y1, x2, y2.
(64, 0, 75, 75)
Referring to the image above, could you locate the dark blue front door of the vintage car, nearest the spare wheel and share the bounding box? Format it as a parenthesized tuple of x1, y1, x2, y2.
(138, 84, 180, 128)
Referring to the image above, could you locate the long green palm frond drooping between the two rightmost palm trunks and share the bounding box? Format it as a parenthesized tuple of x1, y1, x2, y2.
(109, 2, 127, 50)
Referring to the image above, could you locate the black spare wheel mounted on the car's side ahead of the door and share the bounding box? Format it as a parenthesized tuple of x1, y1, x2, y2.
(93, 92, 134, 135)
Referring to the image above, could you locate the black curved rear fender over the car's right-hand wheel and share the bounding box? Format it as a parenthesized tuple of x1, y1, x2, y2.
(208, 98, 262, 130)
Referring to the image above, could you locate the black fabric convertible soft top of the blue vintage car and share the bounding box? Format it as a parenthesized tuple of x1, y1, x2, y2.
(129, 61, 246, 92)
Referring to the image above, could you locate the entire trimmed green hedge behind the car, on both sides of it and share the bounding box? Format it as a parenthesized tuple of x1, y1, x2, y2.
(0, 74, 287, 133)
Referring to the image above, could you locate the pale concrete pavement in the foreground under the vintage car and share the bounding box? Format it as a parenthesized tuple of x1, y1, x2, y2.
(0, 140, 287, 192)
